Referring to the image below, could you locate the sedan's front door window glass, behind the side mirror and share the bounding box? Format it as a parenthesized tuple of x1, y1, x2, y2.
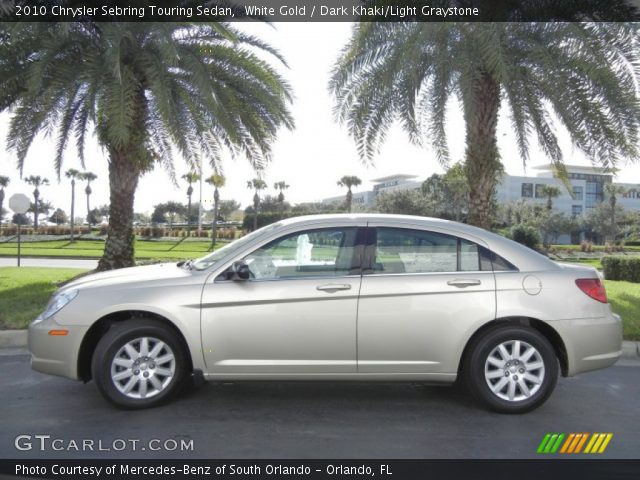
(244, 228, 357, 280)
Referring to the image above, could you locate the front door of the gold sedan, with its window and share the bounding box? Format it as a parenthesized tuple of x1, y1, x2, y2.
(201, 226, 363, 375)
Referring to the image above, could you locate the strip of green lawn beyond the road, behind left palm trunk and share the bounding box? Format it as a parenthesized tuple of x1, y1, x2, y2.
(0, 240, 225, 260)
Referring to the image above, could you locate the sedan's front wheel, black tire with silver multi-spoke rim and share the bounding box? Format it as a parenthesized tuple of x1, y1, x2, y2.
(91, 318, 187, 409)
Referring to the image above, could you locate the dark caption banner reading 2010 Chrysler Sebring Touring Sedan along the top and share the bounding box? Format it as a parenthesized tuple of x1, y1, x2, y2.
(0, 0, 640, 22)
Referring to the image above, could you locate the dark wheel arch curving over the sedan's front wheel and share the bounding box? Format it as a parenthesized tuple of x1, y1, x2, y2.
(77, 310, 193, 383)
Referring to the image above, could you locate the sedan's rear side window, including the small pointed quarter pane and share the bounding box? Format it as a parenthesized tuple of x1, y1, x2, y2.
(373, 228, 516, 273)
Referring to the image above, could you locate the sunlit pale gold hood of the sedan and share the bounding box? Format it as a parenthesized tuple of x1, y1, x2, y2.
(61, 263, 192, 291)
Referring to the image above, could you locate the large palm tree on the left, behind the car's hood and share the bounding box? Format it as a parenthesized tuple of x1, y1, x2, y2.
(0, 23, 293, 270)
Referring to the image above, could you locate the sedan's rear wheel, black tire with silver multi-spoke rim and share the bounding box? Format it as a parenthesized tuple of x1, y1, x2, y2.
(463, 326, 558, 413)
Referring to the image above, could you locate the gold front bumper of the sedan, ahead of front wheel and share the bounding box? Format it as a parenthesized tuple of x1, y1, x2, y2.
(29, 315, 89, 380)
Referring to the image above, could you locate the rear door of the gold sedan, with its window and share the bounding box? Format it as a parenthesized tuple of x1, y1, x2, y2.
(358, 226, 496, 374)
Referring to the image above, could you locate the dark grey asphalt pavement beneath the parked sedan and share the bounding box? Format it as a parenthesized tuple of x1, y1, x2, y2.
(0, 350, 640, 458)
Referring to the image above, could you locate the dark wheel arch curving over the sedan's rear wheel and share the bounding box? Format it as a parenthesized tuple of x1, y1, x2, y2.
(458, 317, 569, 377)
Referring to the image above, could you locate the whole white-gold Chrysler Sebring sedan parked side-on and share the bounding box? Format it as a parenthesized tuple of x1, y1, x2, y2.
(29, 215, 622, 412)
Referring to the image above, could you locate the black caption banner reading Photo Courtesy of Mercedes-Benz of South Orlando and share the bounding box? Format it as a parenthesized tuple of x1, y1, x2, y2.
(0, 459, 640, 480)
